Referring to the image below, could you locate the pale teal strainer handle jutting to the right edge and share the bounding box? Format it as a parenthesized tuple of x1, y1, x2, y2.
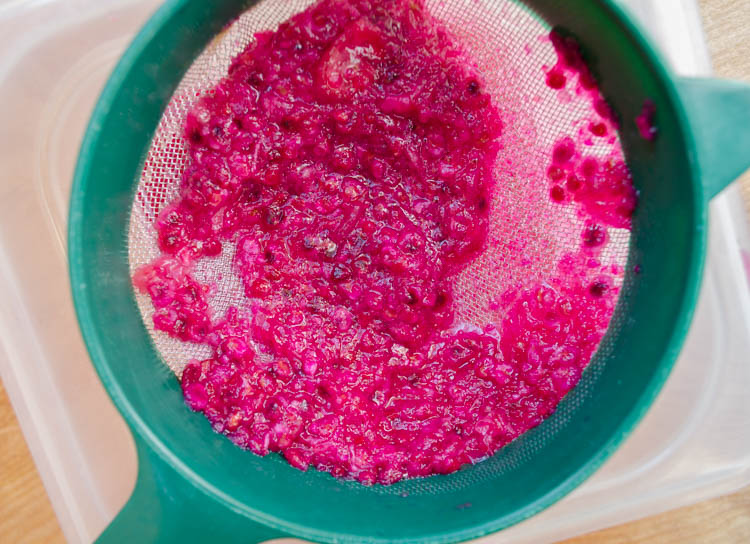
(677, 78, 750, 200)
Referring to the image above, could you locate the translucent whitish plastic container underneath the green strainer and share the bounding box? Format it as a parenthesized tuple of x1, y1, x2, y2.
(0, 0, 750, 542)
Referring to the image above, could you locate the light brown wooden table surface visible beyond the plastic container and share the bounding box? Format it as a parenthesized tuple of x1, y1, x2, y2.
(0, 0, 750, 544)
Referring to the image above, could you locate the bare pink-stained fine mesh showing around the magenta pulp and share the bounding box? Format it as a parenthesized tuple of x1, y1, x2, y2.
(129, 0, 629, 380)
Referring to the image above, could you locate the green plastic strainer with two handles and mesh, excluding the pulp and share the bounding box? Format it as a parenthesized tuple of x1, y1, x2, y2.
(69, 0, 750, 542)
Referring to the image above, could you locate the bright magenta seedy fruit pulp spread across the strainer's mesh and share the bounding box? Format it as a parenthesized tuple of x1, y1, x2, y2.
(133, 0, 635, 484)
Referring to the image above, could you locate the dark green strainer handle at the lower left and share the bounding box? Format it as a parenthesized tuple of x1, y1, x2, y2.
(96, 437, 288, 544)
